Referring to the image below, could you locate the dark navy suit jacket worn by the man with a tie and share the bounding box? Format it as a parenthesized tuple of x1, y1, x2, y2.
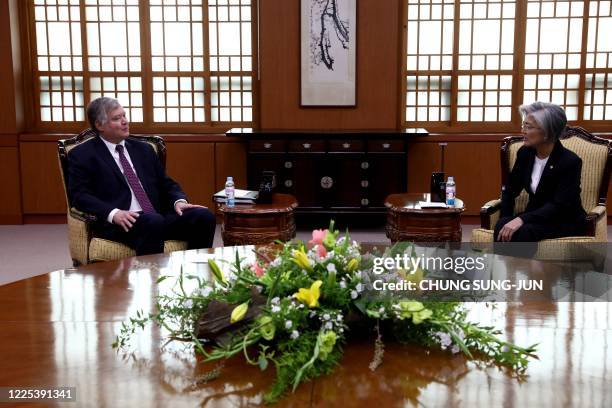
(68, 136, 187, 223)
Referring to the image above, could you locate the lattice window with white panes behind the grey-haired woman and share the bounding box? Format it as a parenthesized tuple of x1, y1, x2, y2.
(402, 0, 612, 131)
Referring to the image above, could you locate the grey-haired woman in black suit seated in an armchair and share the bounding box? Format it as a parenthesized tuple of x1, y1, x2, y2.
(495, 102, 586, 242)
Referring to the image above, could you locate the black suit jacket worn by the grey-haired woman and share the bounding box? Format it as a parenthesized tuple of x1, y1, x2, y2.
(501, 141, 586, 225)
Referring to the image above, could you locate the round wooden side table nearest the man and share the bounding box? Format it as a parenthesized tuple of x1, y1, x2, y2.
(217, 194, 298, 245)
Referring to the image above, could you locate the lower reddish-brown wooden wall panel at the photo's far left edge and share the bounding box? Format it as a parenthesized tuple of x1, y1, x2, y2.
(0, 147, 21, 224)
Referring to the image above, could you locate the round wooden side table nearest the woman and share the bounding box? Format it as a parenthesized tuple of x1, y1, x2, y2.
(385, 193, 465, 242)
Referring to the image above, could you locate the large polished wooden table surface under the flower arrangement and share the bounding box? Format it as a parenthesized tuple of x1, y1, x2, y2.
(0, 247, 612, 407)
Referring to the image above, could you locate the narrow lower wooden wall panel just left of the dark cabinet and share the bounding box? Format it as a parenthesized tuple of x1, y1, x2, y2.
(215, 143, 247, 193)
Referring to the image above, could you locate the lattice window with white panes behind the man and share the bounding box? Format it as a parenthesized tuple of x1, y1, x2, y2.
(28, 0, 256, 131)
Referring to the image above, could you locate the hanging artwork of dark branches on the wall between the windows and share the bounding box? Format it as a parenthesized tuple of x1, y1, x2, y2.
(300, 0, 357, 107)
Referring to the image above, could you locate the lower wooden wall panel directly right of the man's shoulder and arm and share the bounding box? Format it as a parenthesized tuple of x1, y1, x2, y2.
(166, 141, 216, 208)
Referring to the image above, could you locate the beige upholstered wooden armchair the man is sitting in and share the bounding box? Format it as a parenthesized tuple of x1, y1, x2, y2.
(58, 129, 187, 266)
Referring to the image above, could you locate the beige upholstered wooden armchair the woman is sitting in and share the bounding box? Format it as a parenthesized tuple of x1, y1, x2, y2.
(472, 127, 612, 259)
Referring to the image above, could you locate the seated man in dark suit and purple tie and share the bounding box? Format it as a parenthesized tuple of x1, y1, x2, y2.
(68, 98, 215, 255)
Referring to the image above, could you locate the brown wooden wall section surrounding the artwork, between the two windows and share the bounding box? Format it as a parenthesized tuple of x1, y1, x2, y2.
(259, 0, 400, 129)
